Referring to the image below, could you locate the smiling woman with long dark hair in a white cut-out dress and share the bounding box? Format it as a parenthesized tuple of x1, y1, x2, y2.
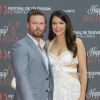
(46, 10, 87, 100)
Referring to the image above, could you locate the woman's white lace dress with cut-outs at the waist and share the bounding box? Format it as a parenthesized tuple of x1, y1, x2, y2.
(48, 41, 80, 100)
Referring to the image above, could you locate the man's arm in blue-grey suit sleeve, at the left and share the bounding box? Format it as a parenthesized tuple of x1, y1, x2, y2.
(12, 43, 34, 100)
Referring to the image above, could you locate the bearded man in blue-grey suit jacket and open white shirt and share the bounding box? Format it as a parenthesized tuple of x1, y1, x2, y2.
(12, 10, 52, 100)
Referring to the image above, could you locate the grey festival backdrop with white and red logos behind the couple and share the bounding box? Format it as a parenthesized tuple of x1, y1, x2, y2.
(0, 0, 100, 100)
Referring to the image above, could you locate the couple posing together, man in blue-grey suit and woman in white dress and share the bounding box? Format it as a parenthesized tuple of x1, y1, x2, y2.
(12, 10, 87, 100)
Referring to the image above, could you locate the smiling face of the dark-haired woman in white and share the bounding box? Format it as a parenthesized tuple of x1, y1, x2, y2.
(52, 16, 66, 36)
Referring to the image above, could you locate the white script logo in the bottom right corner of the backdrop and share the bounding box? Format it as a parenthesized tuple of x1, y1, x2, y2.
(86, 88, 100, 100)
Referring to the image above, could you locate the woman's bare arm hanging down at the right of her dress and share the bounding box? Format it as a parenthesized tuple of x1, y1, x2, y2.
(76, 38, 87, 100)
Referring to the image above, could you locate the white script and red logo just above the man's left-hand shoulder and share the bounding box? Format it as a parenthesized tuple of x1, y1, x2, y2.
(0, 22, 20, 43)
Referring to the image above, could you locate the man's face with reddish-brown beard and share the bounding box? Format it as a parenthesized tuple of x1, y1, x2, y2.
(27, 15, 46, 38)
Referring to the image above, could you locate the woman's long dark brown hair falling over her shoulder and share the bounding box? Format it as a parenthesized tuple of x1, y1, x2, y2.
(48, 10, 77, 57)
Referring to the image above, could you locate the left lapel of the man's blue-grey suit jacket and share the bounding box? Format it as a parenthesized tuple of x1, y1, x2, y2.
(25, 36, 47, 73)
